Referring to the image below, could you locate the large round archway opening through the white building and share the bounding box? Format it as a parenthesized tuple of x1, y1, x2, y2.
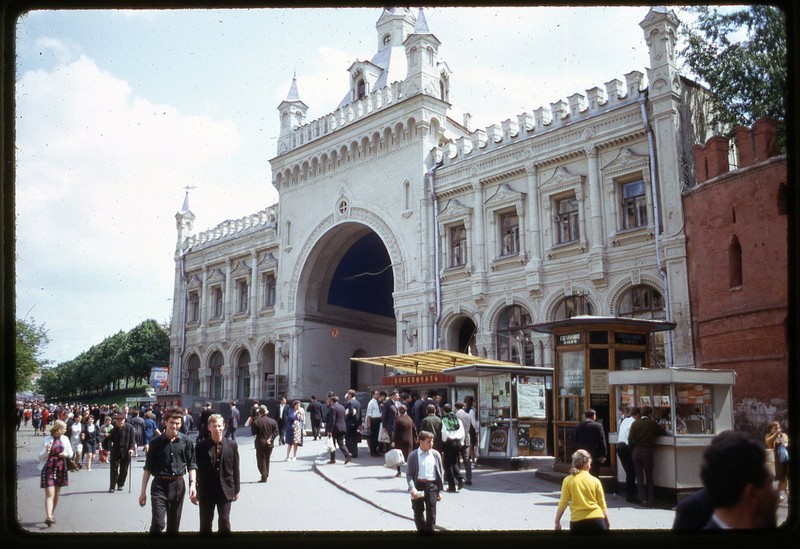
(292, 222, 397, 395)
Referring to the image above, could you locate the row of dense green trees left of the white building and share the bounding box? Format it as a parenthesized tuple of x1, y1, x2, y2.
(39, 320, 169, 399)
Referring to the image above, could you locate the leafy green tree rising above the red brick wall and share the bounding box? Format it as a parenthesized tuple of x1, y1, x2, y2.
(678, 5, 788, 150)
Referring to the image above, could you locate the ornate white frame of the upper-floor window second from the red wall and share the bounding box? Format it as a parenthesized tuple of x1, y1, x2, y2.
(540, 166, 589, 259)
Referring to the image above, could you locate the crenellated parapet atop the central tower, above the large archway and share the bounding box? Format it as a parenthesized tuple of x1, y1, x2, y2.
(278, 81, 404, 156)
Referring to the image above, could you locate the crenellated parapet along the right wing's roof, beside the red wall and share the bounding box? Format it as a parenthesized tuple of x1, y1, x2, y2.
(442, 71, 644, 165)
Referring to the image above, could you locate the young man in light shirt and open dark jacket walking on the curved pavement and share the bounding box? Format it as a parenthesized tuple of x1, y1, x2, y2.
(406, 431, 444, 535)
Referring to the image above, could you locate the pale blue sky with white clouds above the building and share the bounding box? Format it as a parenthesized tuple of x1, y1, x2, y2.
(15, 6, 700, 364)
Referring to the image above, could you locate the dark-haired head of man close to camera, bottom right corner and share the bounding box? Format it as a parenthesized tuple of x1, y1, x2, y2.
(700, 428, 778, 530)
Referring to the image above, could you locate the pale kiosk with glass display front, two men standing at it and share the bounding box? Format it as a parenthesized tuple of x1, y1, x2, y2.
(608, 368, 736, 490)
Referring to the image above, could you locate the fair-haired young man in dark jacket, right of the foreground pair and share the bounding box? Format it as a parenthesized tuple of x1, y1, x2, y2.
(191, 414, 240, 535)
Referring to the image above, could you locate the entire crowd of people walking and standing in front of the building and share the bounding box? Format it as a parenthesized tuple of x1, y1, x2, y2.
(17, 390, 789, 534)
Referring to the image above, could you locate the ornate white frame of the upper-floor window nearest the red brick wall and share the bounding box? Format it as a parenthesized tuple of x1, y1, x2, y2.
(601, 147, 655, 247)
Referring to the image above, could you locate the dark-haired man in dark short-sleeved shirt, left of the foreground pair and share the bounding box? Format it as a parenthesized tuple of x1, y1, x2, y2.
(139, 408, 197, 535)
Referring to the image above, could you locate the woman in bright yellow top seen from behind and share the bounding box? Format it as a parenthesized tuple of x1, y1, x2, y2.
(556, 450, 610, 532)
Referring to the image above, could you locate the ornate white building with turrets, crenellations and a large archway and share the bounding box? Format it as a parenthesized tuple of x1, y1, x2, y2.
(170, 8, 696, 400)
